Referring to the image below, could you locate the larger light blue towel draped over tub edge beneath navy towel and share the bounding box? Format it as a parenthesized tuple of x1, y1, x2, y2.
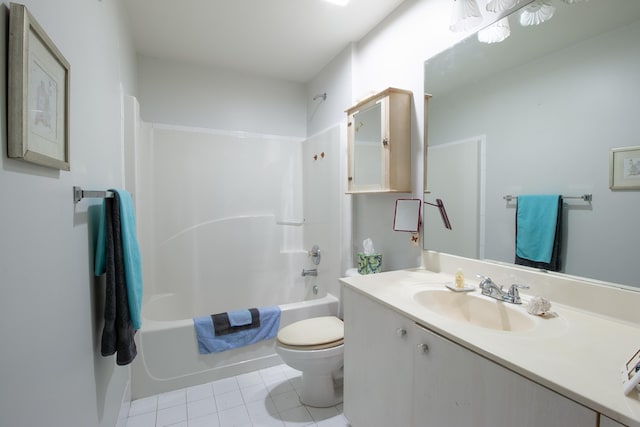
(193, 306, 280, 354)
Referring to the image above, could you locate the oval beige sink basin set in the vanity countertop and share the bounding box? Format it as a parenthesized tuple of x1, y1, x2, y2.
(413, 290, 536, 332)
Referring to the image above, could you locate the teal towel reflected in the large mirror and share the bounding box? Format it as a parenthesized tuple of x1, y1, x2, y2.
(516, 194, 560, 263)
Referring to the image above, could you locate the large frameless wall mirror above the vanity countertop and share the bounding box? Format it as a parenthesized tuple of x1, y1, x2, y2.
(423, 0, 640, 288)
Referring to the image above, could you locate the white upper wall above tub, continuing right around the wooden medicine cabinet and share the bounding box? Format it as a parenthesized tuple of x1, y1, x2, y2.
(132, 0, 484, 276)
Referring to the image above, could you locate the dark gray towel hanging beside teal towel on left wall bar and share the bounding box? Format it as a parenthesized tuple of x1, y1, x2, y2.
(101, 194, 137, 365)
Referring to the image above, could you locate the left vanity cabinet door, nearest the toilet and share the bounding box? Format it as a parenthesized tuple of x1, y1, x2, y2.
(343, 288, 413, 427)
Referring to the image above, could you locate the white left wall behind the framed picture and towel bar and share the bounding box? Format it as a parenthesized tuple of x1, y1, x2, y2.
(0, 0, 136, 427)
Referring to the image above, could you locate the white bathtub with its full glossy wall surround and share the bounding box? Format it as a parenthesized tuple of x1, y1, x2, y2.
(127, 120, 339, 399)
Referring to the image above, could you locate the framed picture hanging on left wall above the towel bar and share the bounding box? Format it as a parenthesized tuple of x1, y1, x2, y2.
(7, 3, 70, 171)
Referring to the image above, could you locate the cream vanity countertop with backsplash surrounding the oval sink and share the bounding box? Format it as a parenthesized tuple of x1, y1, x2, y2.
(340, 252, 640, 427)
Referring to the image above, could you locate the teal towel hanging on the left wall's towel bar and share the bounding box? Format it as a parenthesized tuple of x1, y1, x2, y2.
(94, 189, 142, 330)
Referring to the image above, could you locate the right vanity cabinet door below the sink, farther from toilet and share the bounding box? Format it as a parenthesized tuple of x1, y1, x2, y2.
(412, 325, 598, 427)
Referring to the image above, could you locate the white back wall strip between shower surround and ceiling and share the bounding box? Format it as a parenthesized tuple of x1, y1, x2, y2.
(138, 56, 307, 137)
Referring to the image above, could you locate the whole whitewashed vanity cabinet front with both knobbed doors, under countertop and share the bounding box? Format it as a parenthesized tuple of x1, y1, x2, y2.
(343, 287, 598, 427)
